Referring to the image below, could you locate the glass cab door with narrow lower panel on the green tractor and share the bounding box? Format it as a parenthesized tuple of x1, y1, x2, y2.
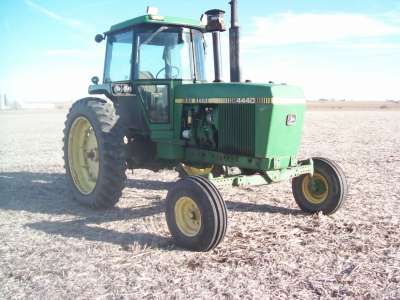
(133, 26, 193, 140)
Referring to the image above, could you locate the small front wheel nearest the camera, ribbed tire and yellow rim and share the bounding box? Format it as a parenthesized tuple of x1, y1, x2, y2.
(166, 176, 227, 251)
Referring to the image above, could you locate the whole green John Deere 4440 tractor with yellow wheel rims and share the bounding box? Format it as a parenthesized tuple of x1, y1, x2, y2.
(63, 0, 347, 251)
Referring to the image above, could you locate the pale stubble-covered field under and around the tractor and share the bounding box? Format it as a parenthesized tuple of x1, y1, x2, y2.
(0, 110, 400, 299)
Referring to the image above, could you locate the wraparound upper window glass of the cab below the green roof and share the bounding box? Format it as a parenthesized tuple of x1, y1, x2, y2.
(104, 26, 205, 82)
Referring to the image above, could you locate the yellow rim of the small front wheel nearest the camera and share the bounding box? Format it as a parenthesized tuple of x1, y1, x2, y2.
(175, 197, 201, 237)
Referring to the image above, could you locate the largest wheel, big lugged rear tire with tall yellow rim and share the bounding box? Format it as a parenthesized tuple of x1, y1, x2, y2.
(63, 98, 126, 208)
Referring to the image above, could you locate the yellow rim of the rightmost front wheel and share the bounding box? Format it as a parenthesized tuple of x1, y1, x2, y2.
(301, 172, 329, 204)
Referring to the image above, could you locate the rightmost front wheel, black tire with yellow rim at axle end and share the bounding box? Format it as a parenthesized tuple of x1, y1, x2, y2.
(292, 158, 348, 215)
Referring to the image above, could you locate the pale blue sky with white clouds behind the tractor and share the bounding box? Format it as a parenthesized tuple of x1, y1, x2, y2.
(0, 0, 400, 101)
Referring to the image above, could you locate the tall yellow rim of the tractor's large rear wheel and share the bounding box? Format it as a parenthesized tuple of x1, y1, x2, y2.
(68, 117, 99, 195)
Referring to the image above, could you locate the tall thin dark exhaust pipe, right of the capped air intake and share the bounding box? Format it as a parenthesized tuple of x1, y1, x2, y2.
(229, 0, 241, 82)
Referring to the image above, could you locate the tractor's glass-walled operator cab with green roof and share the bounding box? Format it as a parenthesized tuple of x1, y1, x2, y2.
(89, 14, 206, 133)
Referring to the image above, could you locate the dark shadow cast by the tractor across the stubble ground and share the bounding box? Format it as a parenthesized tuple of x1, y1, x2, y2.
(0, 172, 302, 250)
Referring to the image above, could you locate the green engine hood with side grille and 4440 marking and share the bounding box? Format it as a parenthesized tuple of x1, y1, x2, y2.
(175, 83, 305, 170)
